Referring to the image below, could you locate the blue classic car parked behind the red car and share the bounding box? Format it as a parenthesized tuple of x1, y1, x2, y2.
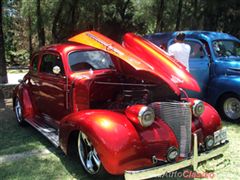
(144, 31, 240, 122)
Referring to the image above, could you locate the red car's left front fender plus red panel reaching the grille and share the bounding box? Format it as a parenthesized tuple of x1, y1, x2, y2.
(59, 110, 178, 174)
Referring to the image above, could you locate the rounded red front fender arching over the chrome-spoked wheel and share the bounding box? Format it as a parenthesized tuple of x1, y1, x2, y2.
(59, 110, 143, 174)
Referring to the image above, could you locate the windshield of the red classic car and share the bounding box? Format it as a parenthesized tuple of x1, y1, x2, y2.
(68, 50, 114, 72)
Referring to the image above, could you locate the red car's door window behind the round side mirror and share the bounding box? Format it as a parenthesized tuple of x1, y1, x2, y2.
(40, 54, 64, 75)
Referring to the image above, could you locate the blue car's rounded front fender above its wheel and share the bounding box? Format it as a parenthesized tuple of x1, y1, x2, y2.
(207, 75, 240, 107)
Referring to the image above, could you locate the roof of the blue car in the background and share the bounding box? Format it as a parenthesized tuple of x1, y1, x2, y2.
(145, 31, 239, 41)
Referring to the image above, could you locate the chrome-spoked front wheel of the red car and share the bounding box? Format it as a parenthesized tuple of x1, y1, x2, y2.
(78, 132, 108, 178)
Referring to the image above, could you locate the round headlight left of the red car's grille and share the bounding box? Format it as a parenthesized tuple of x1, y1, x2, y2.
(138, 106, 155, 127)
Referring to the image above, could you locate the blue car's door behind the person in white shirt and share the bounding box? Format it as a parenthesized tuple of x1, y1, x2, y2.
(168, 38, 210, 99)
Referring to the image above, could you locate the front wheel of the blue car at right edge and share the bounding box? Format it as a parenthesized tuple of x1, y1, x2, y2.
(218, 94, 240, 122)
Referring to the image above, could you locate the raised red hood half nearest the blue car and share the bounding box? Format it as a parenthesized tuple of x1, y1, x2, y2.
(123, 33, 200, 92)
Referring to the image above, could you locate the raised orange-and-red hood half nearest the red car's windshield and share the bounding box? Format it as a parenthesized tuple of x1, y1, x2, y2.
(69, 31, 180, 94)
